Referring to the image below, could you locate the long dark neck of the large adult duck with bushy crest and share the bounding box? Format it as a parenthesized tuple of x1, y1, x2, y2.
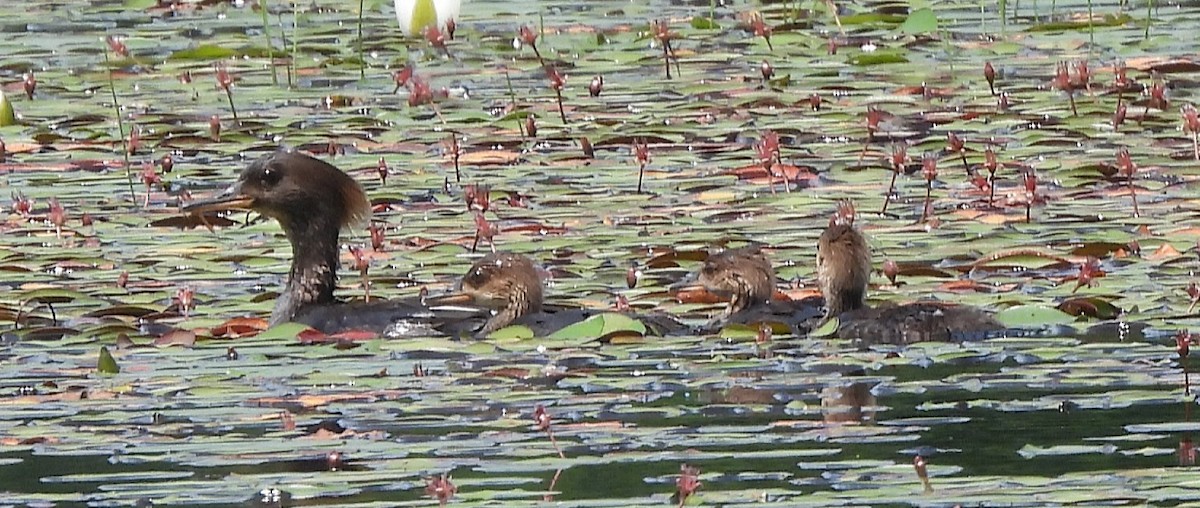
(271, 214, 340, 324)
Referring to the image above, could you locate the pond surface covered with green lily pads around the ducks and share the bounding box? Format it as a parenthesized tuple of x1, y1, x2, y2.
(0, 0, 1200, 507)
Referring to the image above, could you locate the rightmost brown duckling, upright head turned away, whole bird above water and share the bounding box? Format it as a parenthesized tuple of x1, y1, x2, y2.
(817, 221, 1006, 347)
